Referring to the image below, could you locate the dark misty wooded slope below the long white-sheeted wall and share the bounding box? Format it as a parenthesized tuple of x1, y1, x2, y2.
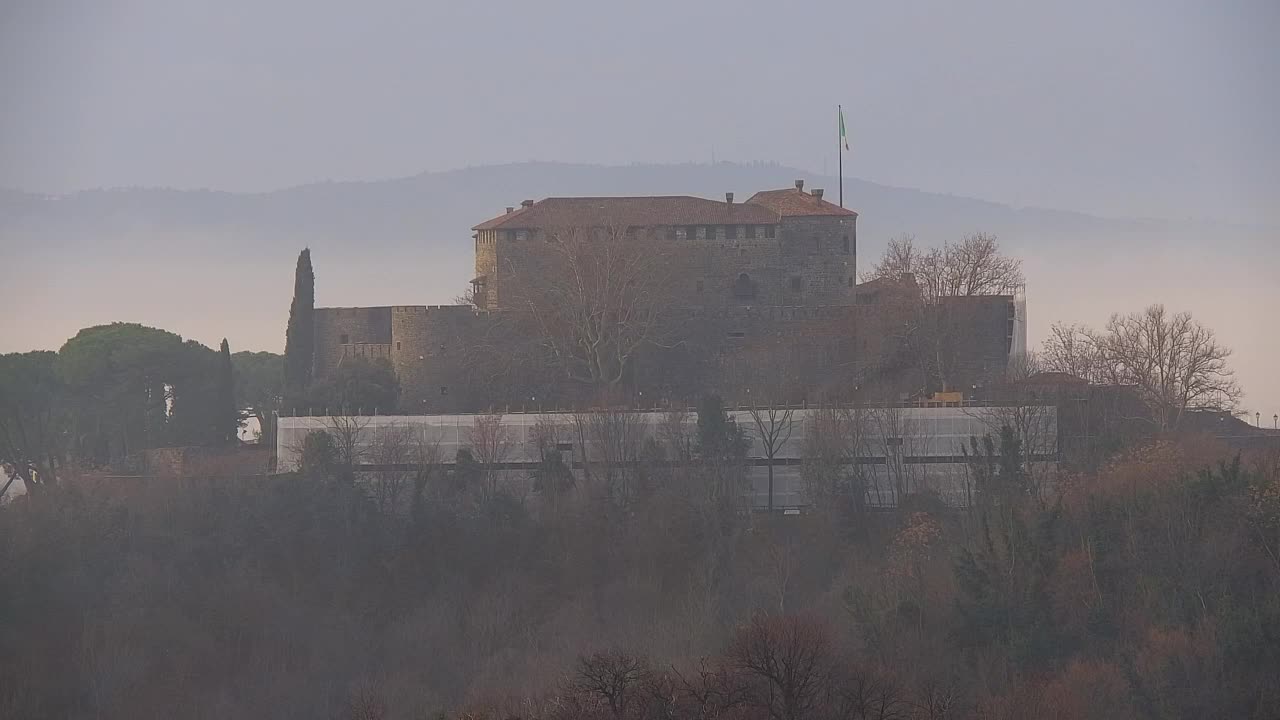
(0, 416, 1280, 720)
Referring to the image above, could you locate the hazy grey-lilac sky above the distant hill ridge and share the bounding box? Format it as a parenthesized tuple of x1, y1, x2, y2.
(0, 0, 1280, 223)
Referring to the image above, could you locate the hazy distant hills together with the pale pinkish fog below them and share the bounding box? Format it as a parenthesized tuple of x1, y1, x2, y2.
(0, 163, 1280, 414)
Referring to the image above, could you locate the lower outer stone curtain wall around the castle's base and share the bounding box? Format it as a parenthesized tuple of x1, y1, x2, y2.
(316, 292, 1009, 413)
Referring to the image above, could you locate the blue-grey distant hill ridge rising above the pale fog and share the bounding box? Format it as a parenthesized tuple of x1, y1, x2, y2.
(0, 163, 1258, 254)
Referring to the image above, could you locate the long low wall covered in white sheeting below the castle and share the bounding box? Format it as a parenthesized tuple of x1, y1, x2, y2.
(276, 406, 1057, 509)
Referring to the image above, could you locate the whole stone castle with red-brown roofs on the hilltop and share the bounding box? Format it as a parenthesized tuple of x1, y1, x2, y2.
(307, 181, 1025, 414)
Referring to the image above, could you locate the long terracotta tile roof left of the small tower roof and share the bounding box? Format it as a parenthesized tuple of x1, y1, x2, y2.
(471, 195, 778, 231)
